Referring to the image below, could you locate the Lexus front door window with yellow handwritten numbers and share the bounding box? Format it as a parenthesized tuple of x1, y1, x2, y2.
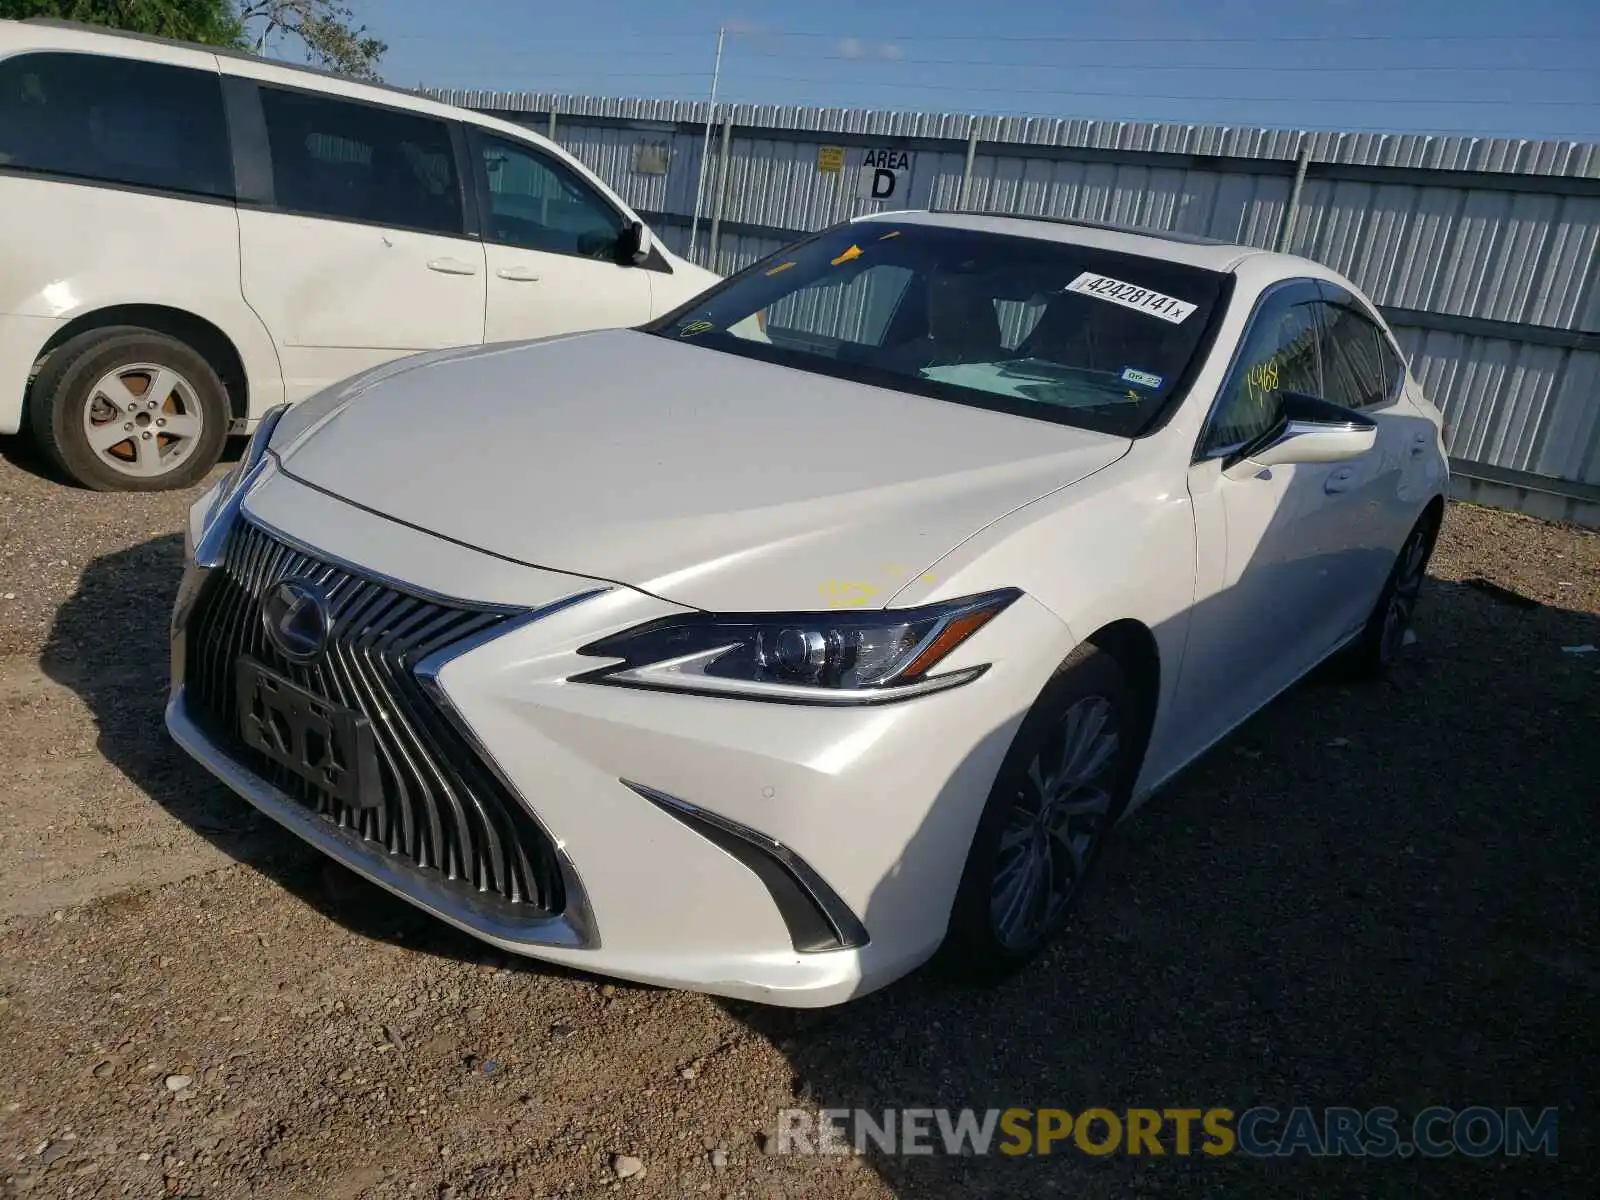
(1203, 288, 1322, 454)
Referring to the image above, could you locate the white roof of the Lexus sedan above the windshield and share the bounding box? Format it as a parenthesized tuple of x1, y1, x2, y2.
(856, 208, 1305, 278)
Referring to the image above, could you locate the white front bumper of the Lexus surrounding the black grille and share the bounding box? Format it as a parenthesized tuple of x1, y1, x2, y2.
(166, 477, 1069, 1006)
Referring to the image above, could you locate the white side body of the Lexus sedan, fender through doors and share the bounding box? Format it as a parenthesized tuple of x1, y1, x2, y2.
(890, 254, 1448, 811)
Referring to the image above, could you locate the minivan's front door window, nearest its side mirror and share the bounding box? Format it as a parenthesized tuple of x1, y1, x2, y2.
(477, 131, 624, 261)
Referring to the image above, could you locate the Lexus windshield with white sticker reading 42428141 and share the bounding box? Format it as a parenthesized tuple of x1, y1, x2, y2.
(646, 221, 1227, 435)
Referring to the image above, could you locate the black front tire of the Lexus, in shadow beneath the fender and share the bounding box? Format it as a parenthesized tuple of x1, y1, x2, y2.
(934, 645, 1149, 984)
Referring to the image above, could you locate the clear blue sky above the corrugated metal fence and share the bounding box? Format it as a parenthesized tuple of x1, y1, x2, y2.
(352, 0, 1600, 141)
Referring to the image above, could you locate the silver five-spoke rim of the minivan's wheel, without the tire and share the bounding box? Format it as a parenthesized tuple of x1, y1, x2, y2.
(83, 363, 205, 477)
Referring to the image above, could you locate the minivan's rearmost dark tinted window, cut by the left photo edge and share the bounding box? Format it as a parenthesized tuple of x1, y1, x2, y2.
(0, 53, 234, 198)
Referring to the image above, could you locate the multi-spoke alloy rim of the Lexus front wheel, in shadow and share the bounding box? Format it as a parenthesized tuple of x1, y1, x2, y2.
(989, 696, 1118, 949)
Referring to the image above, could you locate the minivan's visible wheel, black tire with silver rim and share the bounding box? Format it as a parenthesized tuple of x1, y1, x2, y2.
(29, 325, 230, 491)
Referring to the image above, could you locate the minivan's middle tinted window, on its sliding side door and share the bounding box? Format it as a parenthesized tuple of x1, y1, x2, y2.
(261, 86, 462, 234)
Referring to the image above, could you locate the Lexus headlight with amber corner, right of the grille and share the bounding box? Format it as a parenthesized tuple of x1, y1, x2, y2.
(576, 589, 1021, 704)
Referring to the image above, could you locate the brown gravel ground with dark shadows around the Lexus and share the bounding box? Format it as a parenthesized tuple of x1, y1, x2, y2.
(0, 445, 1600, 1200)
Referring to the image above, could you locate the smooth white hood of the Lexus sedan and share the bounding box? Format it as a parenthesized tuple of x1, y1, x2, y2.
(274, 330, 1130, 611)
